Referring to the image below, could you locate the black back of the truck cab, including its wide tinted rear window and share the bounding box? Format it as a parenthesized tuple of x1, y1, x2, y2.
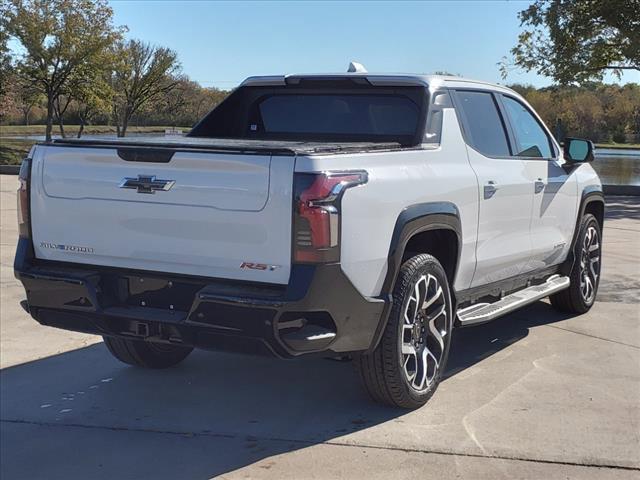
(189, 82, 429, 146)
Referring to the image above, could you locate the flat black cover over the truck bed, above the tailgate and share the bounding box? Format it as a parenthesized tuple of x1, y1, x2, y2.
(53, 136, 403, 156)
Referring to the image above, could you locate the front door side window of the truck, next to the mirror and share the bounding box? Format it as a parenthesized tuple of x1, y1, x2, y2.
(502, 96, 553, 158)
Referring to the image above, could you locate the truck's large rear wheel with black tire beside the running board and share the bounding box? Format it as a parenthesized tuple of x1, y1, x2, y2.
(354, 254, 453, 409)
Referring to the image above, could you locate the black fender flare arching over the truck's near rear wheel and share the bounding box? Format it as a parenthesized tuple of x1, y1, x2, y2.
(369, 202, 462, 351)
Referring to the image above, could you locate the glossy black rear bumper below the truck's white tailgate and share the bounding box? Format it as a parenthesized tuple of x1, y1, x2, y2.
(14, 238, 385, 358)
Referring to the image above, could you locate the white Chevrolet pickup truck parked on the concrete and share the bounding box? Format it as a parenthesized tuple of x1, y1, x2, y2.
(15, 72, 604, 408)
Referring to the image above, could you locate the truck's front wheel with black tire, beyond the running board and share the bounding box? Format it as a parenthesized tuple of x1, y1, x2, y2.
(549, 213, 602, 314)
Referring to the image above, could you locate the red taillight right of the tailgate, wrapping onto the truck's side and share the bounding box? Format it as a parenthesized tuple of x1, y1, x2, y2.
(293, 172, 367, 263)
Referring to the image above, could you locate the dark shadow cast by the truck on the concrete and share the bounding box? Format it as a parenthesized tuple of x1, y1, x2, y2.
(0, 302, 566, 479)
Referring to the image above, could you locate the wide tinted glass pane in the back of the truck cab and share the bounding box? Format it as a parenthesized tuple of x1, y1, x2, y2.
(252, 95, 420, 135)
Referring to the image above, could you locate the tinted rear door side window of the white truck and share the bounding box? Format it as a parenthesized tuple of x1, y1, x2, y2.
(457, 91, 511, 157)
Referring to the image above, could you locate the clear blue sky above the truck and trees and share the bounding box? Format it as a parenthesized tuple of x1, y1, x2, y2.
(111, 0, 640, 89)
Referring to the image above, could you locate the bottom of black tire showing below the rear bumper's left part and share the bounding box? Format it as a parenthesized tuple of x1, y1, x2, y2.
(102, 337, 193, 368)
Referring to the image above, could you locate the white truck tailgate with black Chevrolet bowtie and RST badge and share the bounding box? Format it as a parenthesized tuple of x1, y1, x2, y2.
(31, 145, 295, 284)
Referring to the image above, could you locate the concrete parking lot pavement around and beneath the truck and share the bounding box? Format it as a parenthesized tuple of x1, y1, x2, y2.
(0, 176, 640, 480)
